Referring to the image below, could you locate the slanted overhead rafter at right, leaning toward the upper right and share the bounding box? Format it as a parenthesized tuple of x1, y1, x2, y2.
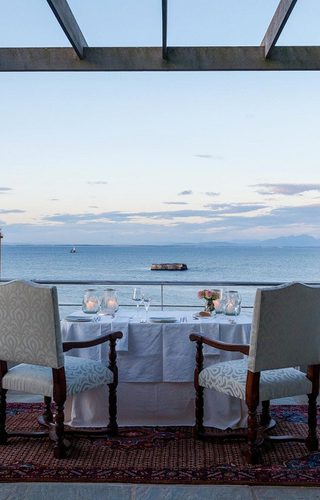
(261, 0, 297, 57)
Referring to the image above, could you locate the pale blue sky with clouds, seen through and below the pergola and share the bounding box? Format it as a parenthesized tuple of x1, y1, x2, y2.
(0, 0, 320, 245)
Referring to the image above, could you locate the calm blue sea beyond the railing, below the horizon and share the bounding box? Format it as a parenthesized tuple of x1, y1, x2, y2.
(1, 243, 320, 312)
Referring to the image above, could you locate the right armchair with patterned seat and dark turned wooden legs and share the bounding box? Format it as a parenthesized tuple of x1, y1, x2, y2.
(190, 283, 320, 463)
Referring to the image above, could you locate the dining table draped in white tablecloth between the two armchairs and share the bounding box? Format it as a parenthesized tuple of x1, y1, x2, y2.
(61, 310, 251, 429)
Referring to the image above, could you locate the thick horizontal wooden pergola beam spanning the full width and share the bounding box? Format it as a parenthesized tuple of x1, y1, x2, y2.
(0, 46, 320, 72)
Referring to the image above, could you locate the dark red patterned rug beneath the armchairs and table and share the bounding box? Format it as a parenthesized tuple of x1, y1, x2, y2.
(0, 404, 320, 486)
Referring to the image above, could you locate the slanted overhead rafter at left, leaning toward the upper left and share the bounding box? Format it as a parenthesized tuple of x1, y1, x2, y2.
(47, 0, 88, 59)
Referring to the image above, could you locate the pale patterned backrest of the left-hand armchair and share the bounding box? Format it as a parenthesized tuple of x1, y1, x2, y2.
(0, 281, 64, 368)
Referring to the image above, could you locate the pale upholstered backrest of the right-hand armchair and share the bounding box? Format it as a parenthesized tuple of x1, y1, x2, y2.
(248, 283, 320, 372)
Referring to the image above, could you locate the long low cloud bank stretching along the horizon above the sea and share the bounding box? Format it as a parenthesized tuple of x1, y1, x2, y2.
(5, 203, 320, 244)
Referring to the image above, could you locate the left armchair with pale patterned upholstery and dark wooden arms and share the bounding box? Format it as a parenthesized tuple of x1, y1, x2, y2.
(0, 281, 122, 458)
